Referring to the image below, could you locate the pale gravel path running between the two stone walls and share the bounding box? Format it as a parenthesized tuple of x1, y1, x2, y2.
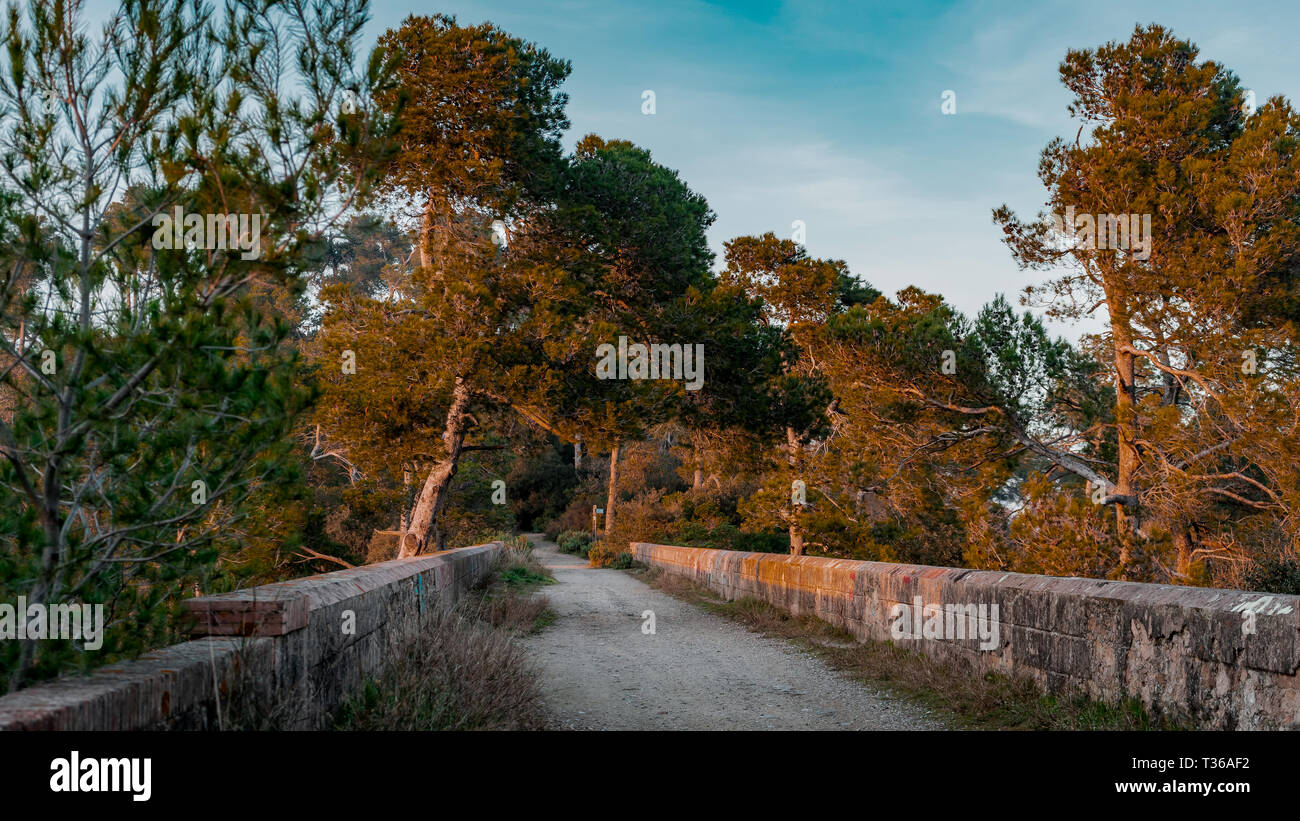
(528, 534, 943, 730)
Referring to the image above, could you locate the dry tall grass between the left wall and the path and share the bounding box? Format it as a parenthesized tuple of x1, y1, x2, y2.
(334, 539, 555, 730)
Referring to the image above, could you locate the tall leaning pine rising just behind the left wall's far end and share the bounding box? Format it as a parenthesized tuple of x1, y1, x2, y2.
(322, 16, 569, 556)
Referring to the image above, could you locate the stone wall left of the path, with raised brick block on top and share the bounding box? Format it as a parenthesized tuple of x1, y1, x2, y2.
(0, 542, 502, 730)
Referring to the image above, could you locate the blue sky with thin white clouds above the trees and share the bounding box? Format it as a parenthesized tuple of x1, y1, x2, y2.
(86, 0, 1300, 339)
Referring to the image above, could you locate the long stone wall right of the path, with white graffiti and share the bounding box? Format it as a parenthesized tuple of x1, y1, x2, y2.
(632, 542, 1300, 730)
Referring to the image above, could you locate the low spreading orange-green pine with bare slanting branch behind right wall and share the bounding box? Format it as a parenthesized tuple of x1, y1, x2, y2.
(816, 288, 1106, 566)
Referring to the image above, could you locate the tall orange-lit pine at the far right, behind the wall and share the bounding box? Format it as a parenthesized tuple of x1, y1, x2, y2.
(995, 26, 1300, 579)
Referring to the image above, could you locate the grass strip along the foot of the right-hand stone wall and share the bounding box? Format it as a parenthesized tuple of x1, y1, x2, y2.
(633, 569, 1187, 730)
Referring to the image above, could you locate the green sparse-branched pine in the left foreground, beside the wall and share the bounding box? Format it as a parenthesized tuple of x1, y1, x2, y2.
(0, 0, 390, 688)
